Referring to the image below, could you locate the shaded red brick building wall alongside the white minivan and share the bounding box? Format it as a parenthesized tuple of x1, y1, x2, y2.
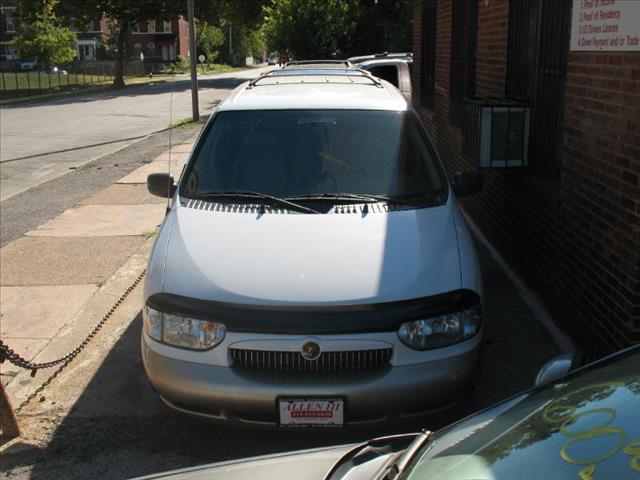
(413, 0, 640, 356)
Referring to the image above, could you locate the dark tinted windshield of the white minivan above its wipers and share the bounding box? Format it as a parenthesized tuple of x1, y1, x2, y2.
(180, 110, 446, 198)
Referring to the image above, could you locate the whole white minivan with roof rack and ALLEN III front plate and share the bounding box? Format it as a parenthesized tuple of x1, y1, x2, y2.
(142, 62, 484, 427)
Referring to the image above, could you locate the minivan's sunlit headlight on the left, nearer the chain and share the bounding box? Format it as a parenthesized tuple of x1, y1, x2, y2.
(143, 306, 227, 350)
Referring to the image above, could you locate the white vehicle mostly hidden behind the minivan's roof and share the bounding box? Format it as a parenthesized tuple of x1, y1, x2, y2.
(347, 53, 413, 102)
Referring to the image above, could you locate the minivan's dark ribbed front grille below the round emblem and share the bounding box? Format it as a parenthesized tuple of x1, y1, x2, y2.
(229, 348, 393, 373)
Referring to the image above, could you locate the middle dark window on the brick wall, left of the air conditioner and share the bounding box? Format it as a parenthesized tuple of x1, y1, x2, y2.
(449, 0, 478, 127)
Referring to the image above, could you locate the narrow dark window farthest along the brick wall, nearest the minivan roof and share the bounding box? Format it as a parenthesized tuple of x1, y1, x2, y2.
(420, 0, 437, 108)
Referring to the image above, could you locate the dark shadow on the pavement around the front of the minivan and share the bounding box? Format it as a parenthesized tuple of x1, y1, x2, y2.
(3, 238, 557, 480)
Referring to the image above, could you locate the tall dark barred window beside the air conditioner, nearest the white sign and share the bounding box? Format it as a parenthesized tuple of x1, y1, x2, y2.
(505, 0, 571, 172)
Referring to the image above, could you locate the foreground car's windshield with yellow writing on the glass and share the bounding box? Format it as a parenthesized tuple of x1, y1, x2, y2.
(405, 349, 640, 480)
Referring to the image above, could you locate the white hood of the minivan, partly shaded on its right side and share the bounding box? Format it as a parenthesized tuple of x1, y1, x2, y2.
(159, 203, 461, 305)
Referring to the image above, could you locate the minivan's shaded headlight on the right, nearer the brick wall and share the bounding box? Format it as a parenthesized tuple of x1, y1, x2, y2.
(398, 305, 482, 350)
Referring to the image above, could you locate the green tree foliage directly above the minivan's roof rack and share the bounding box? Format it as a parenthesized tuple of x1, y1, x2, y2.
(263, 0, 360, 59)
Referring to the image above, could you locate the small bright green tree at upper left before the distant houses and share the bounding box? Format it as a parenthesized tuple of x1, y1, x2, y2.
(13, 0, 77, 68)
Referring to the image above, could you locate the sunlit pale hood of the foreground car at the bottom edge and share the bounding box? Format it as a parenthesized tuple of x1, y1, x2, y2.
(133, 445, 353, 480)
